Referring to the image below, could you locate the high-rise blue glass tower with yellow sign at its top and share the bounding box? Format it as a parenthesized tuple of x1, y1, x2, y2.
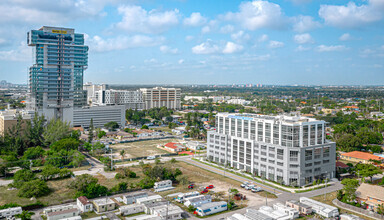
(28, 26, 88, 121)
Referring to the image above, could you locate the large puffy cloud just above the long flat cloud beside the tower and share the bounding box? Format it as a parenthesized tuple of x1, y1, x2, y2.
(115, 6, 179, 34)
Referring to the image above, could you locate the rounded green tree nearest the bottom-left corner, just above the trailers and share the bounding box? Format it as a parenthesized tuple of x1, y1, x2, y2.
(17, 179, 50, 198)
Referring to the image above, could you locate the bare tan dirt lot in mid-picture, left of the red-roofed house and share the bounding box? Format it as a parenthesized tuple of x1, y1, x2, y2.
(110, 139, 179, 159)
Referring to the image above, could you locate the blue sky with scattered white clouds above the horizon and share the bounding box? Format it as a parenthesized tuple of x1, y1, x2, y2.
(0, 0, 384, 85)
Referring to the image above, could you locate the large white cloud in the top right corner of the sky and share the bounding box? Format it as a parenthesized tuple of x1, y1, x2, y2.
(319, 0, 384, 28)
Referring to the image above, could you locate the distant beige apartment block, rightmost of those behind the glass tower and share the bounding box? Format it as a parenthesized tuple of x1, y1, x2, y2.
(140, 87, 181, 109)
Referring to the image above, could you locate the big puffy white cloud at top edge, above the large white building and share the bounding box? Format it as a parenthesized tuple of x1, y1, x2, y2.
(222, 0, 285, 31)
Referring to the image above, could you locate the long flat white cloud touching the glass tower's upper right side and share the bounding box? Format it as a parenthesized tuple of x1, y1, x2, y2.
(85, 35, 164, 52)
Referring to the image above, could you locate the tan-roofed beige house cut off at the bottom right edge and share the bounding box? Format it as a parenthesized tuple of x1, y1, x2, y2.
(356, 183, 384, 211)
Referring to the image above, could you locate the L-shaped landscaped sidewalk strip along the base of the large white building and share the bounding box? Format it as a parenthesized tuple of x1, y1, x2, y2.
(192, 158, 334, 193)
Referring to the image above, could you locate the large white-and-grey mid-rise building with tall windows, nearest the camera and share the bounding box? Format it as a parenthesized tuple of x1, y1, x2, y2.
(207, 113, 336, 186)
